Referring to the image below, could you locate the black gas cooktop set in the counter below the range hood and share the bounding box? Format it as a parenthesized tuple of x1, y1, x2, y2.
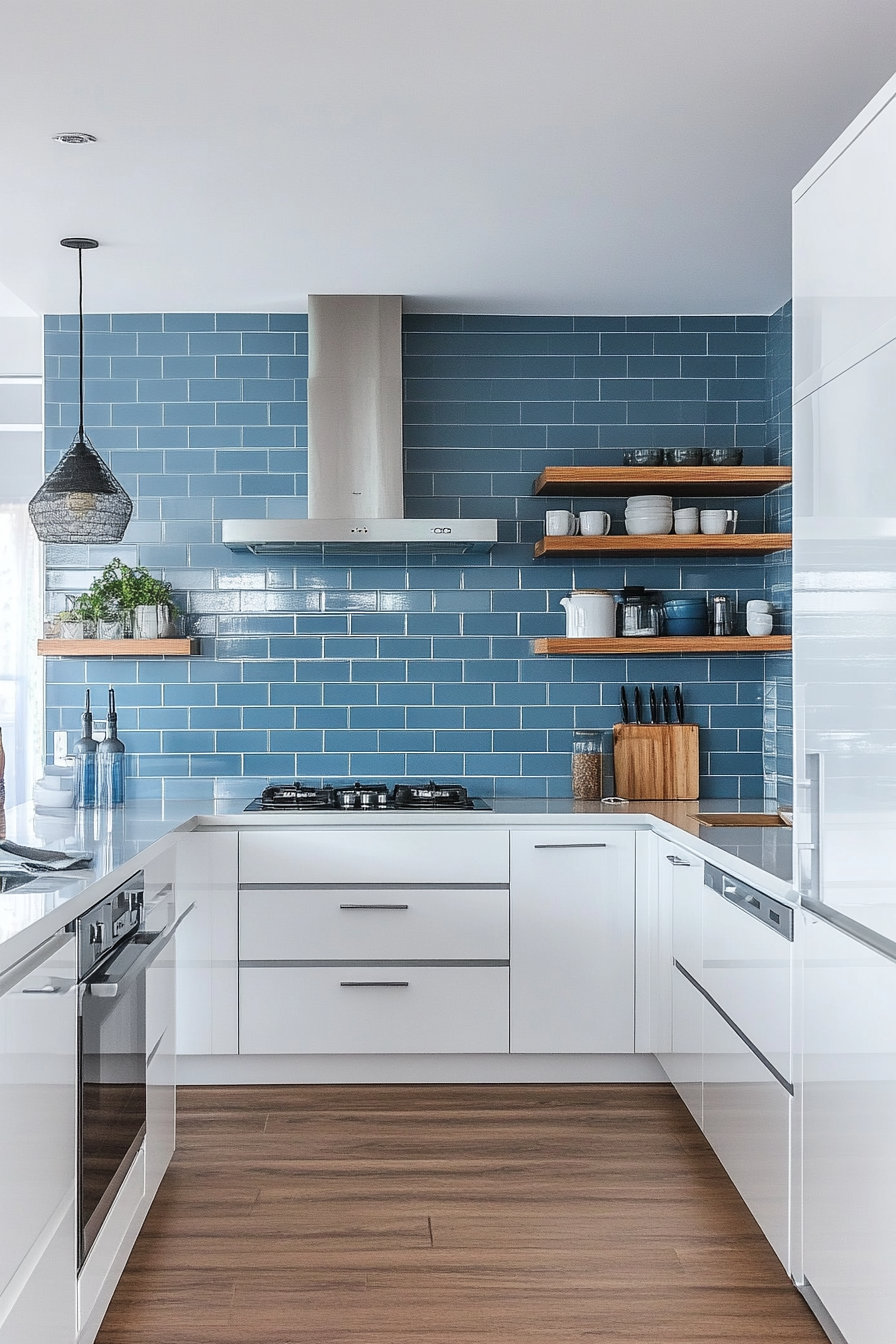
(244, 780, 492, 812)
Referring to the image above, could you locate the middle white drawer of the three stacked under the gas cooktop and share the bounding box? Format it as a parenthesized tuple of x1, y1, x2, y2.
(239, 887, 509, 961)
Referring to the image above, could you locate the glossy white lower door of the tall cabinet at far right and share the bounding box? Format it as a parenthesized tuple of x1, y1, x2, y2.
(801, 915, 896, 1344)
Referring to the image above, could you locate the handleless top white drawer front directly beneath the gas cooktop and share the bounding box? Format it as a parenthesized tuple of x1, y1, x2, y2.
(239, 818, 510, 886)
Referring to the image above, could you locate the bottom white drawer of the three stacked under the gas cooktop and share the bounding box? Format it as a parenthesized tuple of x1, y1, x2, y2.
(239, 966, 509, 1055)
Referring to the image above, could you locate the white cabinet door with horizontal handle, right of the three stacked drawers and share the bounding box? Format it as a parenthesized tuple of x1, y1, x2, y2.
(510, 827, 634, 1054)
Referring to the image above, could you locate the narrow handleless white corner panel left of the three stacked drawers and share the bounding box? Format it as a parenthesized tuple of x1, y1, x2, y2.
(176, 831, 239, 1055)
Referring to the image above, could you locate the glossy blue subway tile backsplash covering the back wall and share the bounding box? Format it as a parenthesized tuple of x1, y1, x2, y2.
(46, 306, 793, 801)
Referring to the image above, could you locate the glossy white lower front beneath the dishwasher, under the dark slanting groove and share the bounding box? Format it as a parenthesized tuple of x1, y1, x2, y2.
(703, 1001, 791, 1266)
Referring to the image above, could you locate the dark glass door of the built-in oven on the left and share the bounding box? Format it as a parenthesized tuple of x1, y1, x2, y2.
(78, 937, 146, 1263)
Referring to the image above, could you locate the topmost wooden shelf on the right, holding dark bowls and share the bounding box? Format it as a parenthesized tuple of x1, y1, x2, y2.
(533, 466, 793, 496)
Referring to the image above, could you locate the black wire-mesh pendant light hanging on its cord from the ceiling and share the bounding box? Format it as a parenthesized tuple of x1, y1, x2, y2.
(28, 238, 133, 543)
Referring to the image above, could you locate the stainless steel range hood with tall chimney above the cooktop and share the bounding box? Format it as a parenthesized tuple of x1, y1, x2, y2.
(222, 294, 497, 555)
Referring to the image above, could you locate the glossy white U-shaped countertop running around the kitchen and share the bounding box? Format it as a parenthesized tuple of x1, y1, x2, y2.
(0, 797, 795, 972)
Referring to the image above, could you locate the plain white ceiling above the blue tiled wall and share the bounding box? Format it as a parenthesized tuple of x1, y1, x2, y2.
(0, 0, 896, 313)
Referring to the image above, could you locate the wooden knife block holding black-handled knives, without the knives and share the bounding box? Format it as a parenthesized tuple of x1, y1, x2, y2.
(613, 723, 700, 800)
